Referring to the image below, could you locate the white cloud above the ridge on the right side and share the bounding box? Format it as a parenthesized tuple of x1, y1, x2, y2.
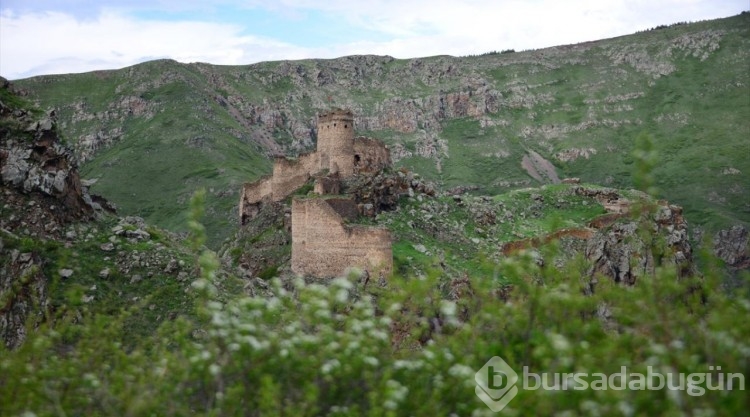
(283, 0, 747, 57)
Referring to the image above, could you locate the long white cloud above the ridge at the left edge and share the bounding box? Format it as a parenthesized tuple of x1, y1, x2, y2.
(0, 11, 312, 79)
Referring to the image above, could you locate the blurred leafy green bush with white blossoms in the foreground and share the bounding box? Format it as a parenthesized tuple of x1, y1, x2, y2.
(0, 190, 750, 416)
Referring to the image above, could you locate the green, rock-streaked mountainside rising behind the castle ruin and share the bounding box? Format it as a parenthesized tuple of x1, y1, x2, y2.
(16, 13, 750, 247)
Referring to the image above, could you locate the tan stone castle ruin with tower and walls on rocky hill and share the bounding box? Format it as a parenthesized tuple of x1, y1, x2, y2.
(239, 109, 393, 277)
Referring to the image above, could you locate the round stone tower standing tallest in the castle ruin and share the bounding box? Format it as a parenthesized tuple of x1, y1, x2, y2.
(318, 109, 354, 177)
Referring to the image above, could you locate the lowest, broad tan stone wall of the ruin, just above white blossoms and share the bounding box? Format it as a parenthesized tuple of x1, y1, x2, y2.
(292, 198, 393, 278)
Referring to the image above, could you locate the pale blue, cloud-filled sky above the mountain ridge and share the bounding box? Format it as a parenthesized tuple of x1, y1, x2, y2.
(0, 0, 750, 80)
